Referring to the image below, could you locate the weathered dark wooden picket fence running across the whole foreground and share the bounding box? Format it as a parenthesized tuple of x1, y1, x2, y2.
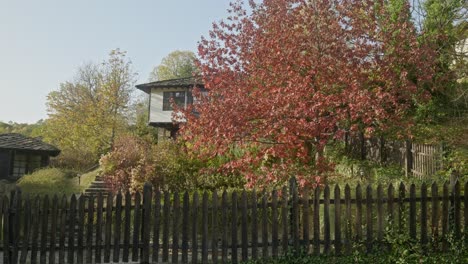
(0, 180, 468, 264)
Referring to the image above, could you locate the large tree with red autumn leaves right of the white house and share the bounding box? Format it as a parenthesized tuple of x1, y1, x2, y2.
(181, 0, 431, 189)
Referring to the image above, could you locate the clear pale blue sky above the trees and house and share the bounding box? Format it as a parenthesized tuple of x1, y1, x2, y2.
(0, 0, 229, 123)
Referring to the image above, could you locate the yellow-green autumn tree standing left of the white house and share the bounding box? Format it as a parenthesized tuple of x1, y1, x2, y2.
(45, 49, 135, 167)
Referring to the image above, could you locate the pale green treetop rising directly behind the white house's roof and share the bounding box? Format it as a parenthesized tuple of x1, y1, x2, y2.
(149, 50, 197, 81)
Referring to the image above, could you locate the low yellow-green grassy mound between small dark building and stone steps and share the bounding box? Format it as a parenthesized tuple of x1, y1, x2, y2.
(17, 168, 99, 196)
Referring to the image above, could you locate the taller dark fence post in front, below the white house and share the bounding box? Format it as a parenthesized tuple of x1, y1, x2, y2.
(141, 183, 153, 263)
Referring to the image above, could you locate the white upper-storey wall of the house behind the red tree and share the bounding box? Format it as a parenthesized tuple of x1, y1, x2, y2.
(149, 88, 188, 123)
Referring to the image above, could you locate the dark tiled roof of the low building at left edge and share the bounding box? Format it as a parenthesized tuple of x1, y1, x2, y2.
(0, 133, 60, 156)
